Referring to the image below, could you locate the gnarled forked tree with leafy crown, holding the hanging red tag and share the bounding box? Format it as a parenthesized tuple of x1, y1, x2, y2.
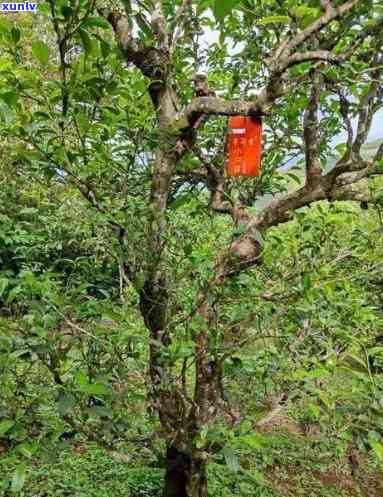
(0, 0, 383, 497)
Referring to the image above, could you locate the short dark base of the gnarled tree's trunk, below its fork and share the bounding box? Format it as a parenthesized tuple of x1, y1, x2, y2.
(163, 446, 207, 497)
